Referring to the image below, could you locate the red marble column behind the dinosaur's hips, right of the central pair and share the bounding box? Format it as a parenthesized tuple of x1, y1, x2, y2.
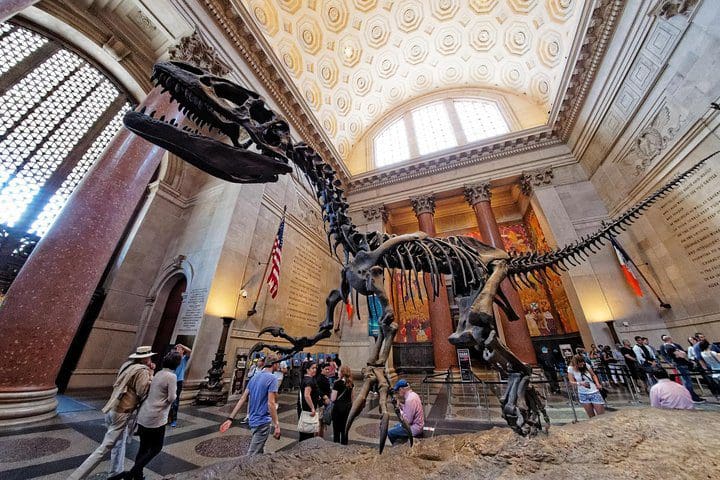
(465, 183, 537, 364)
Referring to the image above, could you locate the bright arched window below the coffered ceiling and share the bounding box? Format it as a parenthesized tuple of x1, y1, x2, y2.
(373, 98, 510, 167)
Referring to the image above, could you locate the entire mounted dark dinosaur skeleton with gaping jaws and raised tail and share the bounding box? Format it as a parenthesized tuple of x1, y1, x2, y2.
(125, 62, 714, 452)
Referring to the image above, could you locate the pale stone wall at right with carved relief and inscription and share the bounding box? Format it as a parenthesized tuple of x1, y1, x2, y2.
(571, 1, 720, 344)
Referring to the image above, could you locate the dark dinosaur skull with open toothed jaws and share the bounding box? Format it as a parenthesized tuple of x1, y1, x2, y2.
(124, 62, 292, 183)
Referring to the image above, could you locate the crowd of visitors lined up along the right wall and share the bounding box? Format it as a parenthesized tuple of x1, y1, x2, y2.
(538, 332, 720, 417)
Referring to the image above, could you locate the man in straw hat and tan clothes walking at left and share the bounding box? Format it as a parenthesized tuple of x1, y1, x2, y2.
(68, 346, 155, 480)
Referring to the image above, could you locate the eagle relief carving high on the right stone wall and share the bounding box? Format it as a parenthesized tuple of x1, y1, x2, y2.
(623, 105, 687, 176)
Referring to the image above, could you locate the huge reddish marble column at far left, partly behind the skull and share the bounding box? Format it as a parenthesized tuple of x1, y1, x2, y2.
(0, 89, 182, 426)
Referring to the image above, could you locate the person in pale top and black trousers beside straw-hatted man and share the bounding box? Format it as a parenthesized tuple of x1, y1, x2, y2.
(108, 350, 182, 480)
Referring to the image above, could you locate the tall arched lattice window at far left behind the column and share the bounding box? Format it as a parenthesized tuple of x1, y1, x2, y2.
(0, 23, 130, 292)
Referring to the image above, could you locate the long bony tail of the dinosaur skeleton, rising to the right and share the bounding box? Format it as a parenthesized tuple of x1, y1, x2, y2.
(508, 151, 720, 286)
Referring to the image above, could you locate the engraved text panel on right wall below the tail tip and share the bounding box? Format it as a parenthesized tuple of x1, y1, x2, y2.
(660, 166, 720, 288)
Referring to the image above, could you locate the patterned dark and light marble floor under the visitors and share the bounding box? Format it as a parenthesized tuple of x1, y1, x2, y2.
(0, 377, 720, 480)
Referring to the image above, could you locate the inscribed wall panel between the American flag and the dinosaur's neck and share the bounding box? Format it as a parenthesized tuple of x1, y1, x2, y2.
(286, 248, 325, 330)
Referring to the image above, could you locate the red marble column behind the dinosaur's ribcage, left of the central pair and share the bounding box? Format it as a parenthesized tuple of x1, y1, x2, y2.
(410, 194, 457, 371)
